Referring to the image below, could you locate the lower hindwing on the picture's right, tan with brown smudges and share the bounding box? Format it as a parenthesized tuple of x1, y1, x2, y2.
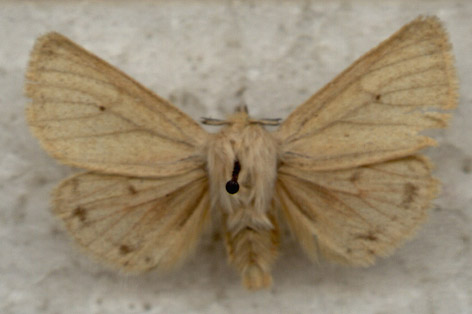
(276, 156, 438, 266)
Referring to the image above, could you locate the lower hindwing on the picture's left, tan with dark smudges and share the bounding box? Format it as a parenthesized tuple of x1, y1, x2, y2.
(53, 169, 209, 273)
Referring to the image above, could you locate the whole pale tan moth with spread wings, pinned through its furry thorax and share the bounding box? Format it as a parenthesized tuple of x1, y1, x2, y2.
(25, 17, 458, 289)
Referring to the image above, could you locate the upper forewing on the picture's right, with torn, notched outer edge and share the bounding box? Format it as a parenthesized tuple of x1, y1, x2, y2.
(275, 17, 457, 171)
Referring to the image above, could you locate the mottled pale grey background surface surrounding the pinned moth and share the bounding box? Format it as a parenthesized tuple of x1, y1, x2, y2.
(0, 0, 472, 314)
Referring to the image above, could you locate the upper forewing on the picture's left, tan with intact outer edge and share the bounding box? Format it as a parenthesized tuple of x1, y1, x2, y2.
(25, 33, 208, 176)
